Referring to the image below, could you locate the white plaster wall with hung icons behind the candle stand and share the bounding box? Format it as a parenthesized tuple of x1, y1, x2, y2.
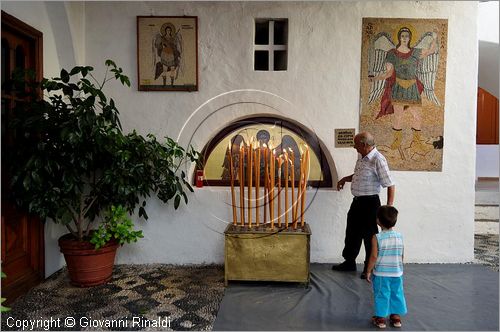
(2, 1, 478, 272)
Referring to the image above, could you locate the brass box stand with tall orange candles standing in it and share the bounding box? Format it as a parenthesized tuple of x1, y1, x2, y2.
(224, 142, 311, 285)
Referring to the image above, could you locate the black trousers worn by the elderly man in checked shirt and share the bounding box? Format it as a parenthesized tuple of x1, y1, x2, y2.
(342, 195, 380, 267)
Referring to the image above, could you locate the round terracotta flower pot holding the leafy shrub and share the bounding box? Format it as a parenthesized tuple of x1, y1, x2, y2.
(59, 234, 119, 287)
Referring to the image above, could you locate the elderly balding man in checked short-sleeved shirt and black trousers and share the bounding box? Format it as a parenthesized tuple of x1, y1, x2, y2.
(332, 132, 395, 279)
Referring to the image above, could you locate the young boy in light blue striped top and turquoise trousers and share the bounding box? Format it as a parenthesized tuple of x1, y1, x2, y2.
(366, 205, 407, 329)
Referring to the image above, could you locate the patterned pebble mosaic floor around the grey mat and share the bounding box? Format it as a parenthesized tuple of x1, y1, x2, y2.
(1, 234, 498, 331)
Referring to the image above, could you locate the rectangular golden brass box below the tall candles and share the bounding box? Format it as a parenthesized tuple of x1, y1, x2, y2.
(224, 223, 311, 286)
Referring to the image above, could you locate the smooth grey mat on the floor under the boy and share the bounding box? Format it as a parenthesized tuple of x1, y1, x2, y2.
(214, 264, 499, 331)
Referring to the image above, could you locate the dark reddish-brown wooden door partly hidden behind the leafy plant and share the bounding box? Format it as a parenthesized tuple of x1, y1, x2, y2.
(2, 11, 45, 303)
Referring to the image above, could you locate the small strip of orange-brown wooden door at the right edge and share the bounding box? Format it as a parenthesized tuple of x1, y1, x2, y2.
(476, 88, 498, 144)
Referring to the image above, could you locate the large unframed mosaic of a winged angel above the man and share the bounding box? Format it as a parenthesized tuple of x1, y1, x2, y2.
(360, 19, 446, 170)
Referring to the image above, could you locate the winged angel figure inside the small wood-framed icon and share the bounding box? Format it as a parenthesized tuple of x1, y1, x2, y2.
(152, 22, 183, 86)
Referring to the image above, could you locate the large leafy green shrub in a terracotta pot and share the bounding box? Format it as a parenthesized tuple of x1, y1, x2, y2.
(9, 60, 200, 286)
